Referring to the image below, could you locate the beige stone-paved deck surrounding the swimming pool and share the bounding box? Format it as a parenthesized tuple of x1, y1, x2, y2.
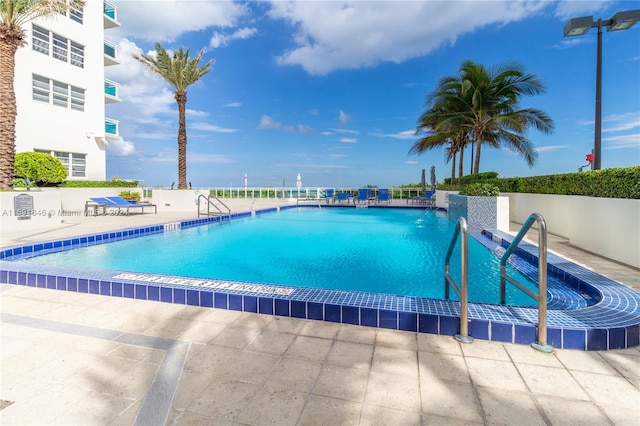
(0, 202, 640, 425)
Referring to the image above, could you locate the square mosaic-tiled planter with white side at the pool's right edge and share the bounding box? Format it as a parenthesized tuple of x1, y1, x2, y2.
(447, 194, 509, 232)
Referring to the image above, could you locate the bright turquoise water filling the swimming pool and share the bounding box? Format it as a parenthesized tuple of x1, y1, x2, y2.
(29, 208, 535, 305)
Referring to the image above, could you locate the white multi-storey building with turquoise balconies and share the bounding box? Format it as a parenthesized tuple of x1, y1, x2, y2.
(15, 0, 120, 180)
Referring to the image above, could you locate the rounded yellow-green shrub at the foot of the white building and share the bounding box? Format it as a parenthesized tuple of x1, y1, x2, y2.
(13, 152, 67, 186)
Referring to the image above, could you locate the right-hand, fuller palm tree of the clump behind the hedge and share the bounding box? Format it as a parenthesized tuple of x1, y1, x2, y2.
(460, 61, 554, 173)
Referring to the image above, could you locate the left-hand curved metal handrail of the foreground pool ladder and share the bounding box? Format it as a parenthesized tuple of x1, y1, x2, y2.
(444, 217, 473, 343)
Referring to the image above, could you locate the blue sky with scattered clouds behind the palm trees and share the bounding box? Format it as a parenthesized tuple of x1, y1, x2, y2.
(105, 0, 640, 188)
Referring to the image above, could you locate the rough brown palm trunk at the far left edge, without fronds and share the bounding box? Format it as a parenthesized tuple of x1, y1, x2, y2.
(0, 31, 22, 191)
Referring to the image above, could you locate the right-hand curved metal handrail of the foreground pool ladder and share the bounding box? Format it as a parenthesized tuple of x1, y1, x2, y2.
(500, 213, 553, 353)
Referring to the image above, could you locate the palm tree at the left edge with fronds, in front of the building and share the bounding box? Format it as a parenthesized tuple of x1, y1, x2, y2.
(0, 0, 84, 190)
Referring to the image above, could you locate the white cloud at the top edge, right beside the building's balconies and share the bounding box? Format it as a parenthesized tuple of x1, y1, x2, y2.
(109, 0, 248, 42)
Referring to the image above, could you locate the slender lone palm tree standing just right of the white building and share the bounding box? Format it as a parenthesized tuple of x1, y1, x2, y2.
(133, 43, 215, 189)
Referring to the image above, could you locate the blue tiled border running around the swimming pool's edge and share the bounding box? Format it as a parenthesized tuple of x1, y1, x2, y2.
(0, 204, 640, 350)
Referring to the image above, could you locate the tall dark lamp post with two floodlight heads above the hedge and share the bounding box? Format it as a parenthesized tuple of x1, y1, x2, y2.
(564, 9, 640, 170)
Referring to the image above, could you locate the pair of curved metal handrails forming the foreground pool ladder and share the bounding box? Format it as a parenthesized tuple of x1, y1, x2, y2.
(444, 213, 553, 353)
